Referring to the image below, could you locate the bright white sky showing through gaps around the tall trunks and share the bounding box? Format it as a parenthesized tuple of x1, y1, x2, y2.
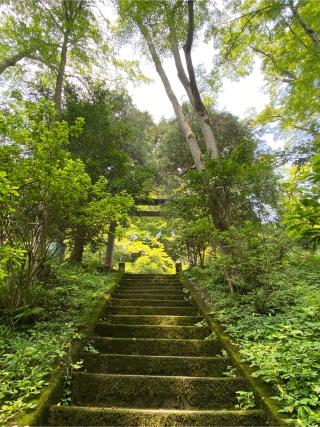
(121, 39, 282, 148)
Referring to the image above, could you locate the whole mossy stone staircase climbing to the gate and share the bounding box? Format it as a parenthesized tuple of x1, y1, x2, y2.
(48, 274, 268, 427)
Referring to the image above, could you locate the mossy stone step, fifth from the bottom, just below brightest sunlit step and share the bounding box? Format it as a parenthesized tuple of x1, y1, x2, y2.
(95, 322, 211, 340)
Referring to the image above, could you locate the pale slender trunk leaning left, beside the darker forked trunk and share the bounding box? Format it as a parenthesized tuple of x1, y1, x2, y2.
(137, 22, 203, 170)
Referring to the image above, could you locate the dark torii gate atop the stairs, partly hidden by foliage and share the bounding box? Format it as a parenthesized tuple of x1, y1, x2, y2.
(103, 199, 167, 271)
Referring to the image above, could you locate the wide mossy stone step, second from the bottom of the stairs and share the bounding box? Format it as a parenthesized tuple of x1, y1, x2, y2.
(71, 372, 247, 409)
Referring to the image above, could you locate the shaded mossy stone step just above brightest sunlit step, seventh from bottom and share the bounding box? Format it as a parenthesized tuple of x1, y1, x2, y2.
(106, 305, 199, 316)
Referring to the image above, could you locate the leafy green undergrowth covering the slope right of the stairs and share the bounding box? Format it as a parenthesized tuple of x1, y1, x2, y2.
(189, 253, 320, 426)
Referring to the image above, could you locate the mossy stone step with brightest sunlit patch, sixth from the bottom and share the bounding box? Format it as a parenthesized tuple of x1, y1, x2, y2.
(103, 315, 202, 326)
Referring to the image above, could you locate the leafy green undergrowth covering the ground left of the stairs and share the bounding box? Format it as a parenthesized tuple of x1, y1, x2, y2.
(0, 266, 112, 424)
